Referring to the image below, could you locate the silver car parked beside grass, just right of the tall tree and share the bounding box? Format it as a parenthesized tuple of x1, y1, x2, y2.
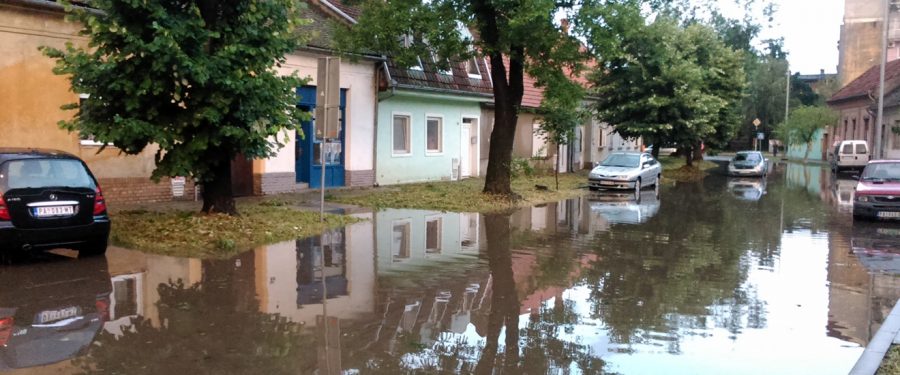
(588, 152, 662, 194)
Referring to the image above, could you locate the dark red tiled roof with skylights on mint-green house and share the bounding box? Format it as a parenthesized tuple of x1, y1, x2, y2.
(387, 58, 493, 95)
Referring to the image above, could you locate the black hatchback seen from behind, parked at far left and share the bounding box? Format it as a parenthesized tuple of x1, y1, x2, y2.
(0, 148, 110, 259)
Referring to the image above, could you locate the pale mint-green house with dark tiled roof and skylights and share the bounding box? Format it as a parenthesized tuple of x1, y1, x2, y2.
(375, 37, 493, 185)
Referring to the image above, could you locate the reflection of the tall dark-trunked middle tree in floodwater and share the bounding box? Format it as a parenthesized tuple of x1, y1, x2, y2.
(344, 215, 604, 374)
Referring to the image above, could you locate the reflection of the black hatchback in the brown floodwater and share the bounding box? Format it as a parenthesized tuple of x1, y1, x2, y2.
(0, 257, 112, 370)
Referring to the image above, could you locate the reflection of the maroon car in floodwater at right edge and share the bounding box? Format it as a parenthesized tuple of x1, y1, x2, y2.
(850, 222, 900, 274)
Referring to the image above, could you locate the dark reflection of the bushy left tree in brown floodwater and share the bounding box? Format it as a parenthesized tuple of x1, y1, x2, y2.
(75, 261, 316, 374)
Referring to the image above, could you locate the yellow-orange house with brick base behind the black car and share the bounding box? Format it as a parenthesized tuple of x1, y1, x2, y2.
(0, 0, 194, 205)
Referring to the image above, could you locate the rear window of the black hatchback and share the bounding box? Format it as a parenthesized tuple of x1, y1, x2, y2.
(0, 159, 96, 193)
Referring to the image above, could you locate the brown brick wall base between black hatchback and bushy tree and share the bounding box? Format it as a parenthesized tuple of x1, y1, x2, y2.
(99, 178, 194, 205)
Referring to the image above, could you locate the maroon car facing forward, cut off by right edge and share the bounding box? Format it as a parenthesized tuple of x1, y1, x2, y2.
(853, 160, 900, 219)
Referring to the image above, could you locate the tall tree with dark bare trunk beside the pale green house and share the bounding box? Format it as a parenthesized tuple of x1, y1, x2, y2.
(336, 0, 665, 195)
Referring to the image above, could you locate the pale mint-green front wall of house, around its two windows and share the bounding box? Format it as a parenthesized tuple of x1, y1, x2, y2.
(375, 90, 484, 185)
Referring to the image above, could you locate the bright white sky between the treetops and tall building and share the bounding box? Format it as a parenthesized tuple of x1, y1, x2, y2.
(718, 0, 844, 74)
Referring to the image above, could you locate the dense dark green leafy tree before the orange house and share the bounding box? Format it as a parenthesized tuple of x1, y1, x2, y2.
(43, 0, 305, 214)
